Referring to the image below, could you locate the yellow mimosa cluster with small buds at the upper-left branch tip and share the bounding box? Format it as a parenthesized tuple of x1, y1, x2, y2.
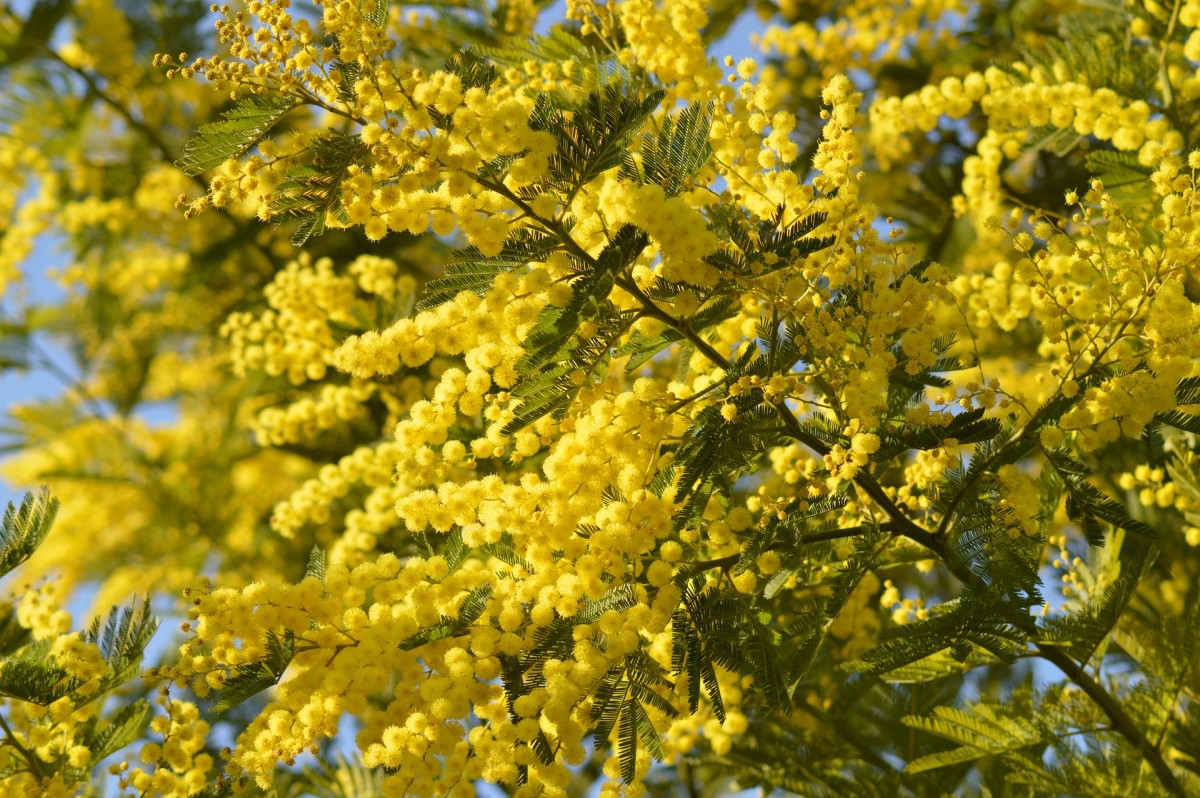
(160, 23, 554, 247)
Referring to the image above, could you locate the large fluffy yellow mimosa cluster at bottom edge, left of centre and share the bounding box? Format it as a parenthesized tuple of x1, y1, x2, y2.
(174, 554, 508, 794)
